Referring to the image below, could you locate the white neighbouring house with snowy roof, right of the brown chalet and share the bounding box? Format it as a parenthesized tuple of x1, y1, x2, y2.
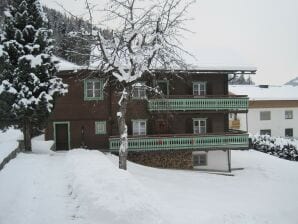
(230, 85, 298, 138)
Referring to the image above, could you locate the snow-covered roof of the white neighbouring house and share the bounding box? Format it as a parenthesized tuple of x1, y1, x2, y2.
(229, 85, 298, 100)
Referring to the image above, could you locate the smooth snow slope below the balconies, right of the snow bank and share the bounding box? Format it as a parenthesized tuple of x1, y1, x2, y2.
(112, 150, 298, 224)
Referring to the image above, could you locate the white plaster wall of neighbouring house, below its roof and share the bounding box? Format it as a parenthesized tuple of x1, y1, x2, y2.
(238, 108, 298, 138)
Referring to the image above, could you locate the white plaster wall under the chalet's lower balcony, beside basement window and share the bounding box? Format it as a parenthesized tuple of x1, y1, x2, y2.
(193, 150, 229, 171)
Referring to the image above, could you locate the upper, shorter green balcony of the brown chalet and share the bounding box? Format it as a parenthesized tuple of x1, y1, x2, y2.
(148, 95, 248, 112)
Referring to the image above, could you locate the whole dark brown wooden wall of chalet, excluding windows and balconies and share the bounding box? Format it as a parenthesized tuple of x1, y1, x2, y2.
(46, 71, 228, 149)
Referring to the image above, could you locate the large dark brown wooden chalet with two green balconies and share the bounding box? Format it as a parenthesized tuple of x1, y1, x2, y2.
(46, 62, 256, 171)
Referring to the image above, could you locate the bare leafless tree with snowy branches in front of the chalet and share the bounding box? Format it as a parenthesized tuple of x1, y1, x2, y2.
(85, 0, 194, 169)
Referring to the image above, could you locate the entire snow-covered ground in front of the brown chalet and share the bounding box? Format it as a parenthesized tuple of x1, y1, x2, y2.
(0, 135, 298, 224)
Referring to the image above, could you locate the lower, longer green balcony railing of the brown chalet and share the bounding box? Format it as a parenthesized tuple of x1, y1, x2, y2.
(109, 134, 248, 151)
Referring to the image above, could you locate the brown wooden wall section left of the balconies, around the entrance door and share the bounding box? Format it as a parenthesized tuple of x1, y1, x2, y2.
(45, 72, 111, 149)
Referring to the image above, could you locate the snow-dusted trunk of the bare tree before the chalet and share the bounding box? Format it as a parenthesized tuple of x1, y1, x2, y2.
(117, 90, 128, 170)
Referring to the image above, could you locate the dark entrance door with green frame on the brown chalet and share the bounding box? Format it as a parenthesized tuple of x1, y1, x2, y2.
(55, 123, 69, 150)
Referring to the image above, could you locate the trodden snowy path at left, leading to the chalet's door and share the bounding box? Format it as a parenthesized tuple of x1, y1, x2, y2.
(0, 154, 75, 224)
